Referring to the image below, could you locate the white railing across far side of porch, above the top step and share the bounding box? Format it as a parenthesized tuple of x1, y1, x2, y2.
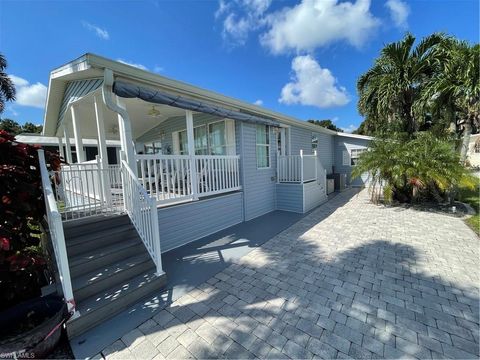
(55, 156, 123, 220)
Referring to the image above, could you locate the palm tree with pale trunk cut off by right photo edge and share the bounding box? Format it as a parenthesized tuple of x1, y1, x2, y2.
(422, 38, 480, 163)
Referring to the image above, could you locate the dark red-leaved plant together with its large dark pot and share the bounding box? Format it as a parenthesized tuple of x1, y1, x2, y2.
(0, 130, 67, 358)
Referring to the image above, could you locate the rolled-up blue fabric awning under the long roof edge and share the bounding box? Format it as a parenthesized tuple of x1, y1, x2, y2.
(113, 81, 280, 126)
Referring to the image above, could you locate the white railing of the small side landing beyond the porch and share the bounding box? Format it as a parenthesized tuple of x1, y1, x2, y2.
(277, 150, 318, 183)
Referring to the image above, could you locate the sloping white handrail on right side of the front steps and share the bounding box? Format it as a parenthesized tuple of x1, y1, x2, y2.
(121, 160, 163, 275)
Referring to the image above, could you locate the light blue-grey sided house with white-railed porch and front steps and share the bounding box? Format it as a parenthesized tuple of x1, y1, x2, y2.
(40, 54, 370, 337)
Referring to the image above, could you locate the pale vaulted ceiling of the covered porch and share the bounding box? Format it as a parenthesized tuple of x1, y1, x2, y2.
(64, 91, 189, 140)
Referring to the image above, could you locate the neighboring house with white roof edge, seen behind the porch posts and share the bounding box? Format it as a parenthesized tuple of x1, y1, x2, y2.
(15, 133, 120, 165)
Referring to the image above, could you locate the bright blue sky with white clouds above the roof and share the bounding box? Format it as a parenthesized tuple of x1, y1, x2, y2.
(0, 0, 479, 130)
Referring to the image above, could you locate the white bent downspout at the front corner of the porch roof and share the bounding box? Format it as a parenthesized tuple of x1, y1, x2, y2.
(102, 69, 137, 175)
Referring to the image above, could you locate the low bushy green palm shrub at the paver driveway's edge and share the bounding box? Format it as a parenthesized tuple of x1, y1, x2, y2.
(352, 132, 475, 202)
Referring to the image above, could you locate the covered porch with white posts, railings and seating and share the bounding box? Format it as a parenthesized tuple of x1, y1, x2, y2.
(57, 82, 241, 218)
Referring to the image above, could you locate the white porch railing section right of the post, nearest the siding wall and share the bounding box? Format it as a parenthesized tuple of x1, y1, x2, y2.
(195, 155, 241, 196)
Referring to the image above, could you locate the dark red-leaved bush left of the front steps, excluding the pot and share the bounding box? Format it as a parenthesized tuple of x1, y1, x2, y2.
(0, 130, 60, 310)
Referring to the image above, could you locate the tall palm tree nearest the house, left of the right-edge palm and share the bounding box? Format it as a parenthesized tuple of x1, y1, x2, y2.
(357, 33, 445, 135)
